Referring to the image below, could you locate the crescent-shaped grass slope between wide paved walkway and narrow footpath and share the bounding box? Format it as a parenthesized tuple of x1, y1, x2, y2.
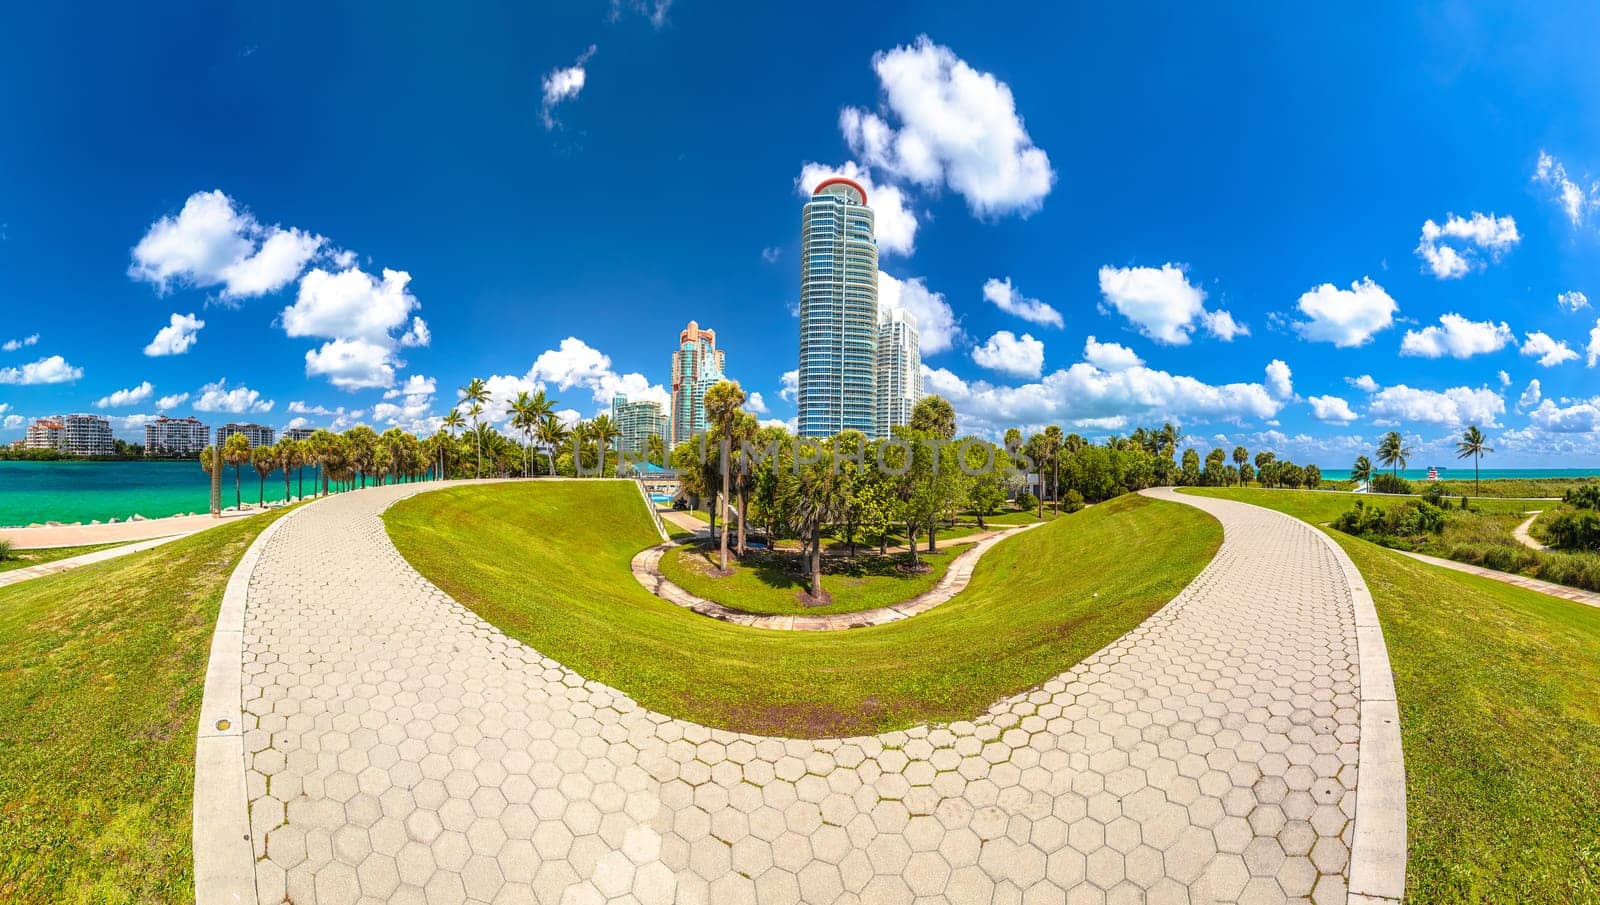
(384, 481, 1222, 737)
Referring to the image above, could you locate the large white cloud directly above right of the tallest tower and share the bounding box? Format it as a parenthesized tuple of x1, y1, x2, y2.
(838, 35, 1056, 216)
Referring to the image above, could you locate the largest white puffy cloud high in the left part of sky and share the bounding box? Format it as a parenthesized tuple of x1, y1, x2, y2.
(128, 190, 328, 299)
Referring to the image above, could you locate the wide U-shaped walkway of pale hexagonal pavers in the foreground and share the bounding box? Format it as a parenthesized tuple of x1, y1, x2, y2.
(195, 484, 1405, 905)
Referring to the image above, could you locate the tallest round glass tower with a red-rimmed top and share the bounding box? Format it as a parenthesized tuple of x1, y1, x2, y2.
(798, 177, 880, 437)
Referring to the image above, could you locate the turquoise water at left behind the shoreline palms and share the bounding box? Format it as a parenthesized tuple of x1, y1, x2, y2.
(0, 462, 315, 526)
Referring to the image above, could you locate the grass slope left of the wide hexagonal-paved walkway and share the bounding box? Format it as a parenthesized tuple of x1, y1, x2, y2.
(0, 510, 286, 903)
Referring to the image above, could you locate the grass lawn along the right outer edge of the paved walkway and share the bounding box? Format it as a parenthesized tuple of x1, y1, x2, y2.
(1195, 489, 1600, 905)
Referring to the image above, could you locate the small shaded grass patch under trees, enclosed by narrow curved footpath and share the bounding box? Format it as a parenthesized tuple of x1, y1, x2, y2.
(661, 544, 968, 616)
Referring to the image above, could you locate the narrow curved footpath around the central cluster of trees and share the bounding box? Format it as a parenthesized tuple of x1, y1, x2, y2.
(632, 524, 1034, 632)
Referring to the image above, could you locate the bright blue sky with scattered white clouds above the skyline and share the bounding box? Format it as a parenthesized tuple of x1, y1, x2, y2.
(0, 0, 1600, 467)
